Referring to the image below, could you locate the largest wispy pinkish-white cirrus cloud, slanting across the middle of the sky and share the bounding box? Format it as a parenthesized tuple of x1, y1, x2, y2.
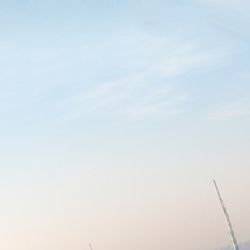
(61, 36, 218, 119)
